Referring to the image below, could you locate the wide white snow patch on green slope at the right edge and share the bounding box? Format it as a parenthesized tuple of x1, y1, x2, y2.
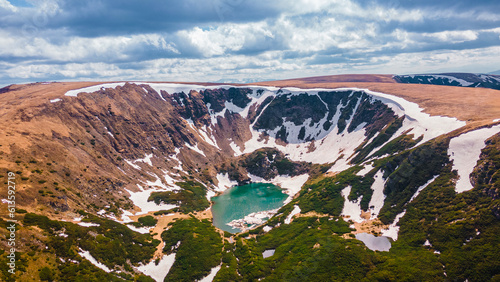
(448, 125, 500, 193)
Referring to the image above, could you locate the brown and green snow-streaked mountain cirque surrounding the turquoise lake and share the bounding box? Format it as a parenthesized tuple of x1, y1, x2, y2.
(0, 78, 500, 281)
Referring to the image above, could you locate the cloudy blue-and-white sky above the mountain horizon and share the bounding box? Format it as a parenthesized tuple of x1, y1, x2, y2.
(0, 0, 500, 86)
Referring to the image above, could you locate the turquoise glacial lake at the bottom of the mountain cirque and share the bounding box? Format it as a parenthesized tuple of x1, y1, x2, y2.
(211, 183, 288, 233)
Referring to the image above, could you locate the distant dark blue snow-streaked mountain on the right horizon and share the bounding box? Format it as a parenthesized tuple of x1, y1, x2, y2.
(394, 73, 500, 90)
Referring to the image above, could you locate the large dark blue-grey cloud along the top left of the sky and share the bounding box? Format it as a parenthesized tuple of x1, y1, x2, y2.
(0, 0, 279, 37)
